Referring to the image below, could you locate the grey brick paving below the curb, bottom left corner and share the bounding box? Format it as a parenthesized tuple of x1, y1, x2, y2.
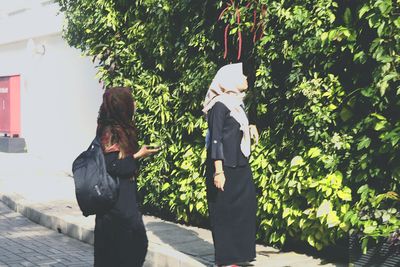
(0, 202, 93, 266)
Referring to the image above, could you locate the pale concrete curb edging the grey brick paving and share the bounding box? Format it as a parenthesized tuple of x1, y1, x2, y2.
(0, 192, 207, 267)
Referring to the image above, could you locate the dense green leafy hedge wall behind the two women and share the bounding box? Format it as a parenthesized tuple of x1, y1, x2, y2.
(57, 0, 400, 249)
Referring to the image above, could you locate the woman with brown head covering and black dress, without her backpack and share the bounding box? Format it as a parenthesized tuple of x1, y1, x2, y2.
(94, 87, 158, 267)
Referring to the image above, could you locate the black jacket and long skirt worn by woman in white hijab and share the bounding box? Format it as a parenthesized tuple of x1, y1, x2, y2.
(206, 102, 257, 265)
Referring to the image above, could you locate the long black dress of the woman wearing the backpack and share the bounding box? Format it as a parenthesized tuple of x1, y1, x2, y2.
(94, 153, 148, 267)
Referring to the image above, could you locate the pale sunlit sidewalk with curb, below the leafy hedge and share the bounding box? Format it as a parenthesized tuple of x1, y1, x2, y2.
(0, 153, 345, 267)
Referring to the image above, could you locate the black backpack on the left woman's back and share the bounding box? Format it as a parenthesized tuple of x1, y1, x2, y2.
(72, 137, 119, 217)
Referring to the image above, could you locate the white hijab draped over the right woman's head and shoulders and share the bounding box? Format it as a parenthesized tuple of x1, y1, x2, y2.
(203, 63, 250, 157)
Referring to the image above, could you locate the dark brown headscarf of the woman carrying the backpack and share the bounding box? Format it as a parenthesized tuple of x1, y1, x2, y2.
(97, 87, 138, 158)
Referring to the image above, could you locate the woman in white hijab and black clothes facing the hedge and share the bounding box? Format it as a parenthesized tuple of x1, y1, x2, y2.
(203, 63, 258, 266)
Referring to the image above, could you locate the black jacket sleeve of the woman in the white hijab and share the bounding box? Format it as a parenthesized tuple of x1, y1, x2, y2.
(208, 102, 229, 160)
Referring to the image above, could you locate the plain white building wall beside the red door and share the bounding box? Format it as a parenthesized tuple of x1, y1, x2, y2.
(0, 0, 103, 171)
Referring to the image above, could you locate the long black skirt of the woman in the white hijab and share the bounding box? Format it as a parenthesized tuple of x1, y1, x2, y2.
(206, 162, 257, 265)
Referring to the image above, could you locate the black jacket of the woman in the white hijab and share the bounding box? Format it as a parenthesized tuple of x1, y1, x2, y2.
(207, 102, 248, 167)
